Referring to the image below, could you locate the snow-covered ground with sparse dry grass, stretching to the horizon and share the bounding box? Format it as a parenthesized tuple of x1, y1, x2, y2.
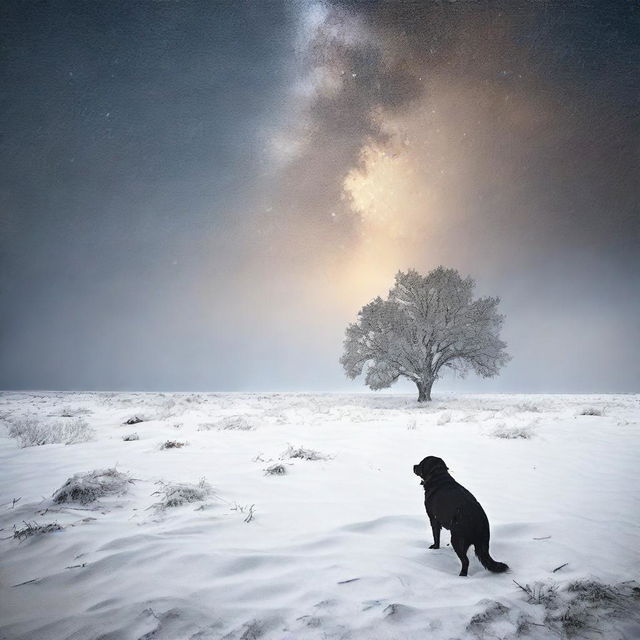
(0, 392, 640, 640)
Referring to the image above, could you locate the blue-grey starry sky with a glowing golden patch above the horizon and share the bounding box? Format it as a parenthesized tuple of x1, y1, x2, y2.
(0, 0, 640, 394)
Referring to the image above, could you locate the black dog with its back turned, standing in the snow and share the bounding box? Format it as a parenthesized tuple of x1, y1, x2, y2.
(413, 456, 509, 576)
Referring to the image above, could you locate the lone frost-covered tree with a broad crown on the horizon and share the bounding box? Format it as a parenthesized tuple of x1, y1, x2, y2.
(340, 267, 510, 402)
